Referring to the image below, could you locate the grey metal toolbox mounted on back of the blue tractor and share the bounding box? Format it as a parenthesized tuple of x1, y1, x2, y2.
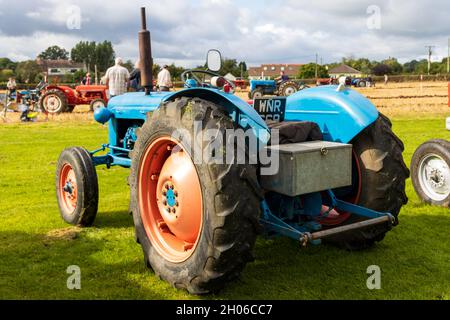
(261, 141, 352, 197)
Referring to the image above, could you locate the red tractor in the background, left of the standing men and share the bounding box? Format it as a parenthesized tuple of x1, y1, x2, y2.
(39, 85, 108, 114)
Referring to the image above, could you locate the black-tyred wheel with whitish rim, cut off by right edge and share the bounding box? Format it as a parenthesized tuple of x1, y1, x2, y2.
(411, 140, 450, 207)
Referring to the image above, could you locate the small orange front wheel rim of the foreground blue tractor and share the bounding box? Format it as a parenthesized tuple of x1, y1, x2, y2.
(59, 163, 78, 213)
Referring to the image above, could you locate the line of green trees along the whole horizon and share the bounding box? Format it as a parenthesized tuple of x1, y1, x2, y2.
(0, 41, 447, 83)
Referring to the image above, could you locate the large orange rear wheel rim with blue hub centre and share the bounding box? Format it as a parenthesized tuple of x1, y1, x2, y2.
(138, 137, 203, 263)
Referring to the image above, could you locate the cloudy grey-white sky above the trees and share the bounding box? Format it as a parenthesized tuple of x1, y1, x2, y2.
(0, 0, 450, 67)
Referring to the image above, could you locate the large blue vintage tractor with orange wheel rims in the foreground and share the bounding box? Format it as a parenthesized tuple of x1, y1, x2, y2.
(56, 9, 409, 294)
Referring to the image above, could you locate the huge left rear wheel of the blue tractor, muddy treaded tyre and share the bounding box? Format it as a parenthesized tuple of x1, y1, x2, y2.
(129, 97, 262, 294)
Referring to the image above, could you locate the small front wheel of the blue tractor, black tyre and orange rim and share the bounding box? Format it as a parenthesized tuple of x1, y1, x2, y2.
(56, 147, 98, 227)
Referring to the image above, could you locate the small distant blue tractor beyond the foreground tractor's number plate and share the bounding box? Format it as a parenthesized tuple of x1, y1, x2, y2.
(248, 80, 308, 99)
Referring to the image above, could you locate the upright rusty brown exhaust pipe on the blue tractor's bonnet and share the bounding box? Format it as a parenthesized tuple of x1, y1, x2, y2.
(138, 8, 153, 95)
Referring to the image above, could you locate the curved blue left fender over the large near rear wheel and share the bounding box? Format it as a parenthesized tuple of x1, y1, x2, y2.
(167, 88, 270, 144)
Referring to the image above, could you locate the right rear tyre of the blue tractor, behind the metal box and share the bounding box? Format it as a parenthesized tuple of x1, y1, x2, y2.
(330, 114, 409, 250)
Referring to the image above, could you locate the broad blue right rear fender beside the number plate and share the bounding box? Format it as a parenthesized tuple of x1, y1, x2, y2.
(285, 86, 379, 143)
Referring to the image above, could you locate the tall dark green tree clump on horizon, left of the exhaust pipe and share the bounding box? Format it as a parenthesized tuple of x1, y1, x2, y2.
(70, 41, 115, 72)
